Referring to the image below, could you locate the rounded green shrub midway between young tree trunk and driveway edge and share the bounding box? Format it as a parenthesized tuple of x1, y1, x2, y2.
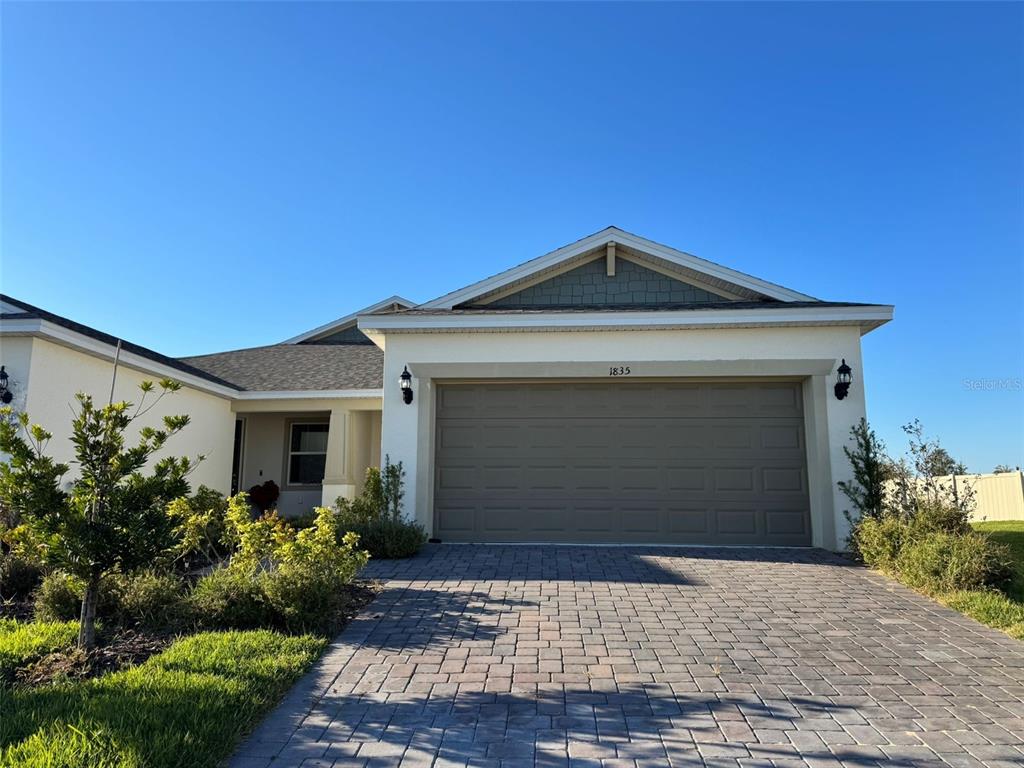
(188, 567, 273, 630)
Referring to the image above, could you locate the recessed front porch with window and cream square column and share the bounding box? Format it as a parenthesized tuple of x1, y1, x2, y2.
(231, 398, 381, 517)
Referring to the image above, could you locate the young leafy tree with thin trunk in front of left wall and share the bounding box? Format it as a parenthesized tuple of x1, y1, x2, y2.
(0, 379, 195, 648)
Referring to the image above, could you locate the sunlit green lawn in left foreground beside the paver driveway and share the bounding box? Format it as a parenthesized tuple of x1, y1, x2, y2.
(0, 630, 326, 768)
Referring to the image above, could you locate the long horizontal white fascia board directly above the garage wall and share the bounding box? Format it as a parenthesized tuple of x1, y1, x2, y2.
(359, 305, 893, 333)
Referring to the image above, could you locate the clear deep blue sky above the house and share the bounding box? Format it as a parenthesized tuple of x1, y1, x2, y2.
(0, 2, 1024, 471)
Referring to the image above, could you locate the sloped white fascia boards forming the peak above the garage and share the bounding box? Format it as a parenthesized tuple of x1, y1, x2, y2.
(420, 226, 816, 309)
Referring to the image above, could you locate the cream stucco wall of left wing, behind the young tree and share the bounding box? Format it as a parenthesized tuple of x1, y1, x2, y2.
(0, 336, 234, 493)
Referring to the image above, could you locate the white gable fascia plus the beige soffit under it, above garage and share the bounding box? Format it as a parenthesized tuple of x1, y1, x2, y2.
(420, 226, 816, 309)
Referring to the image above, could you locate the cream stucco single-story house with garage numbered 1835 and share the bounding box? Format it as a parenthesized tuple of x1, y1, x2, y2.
(0, 227, 893, 549)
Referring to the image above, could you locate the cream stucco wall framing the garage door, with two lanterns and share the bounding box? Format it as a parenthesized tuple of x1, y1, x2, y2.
(381, 326, 865, 550)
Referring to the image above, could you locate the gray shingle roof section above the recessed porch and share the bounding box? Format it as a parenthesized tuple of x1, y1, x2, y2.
(181, 344, 384, 391)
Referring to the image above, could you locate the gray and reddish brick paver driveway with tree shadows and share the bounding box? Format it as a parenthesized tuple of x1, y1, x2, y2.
(232, 546, 1024, 768)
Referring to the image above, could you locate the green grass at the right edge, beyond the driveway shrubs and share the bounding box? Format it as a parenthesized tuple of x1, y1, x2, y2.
(939, 520, 1024, 640)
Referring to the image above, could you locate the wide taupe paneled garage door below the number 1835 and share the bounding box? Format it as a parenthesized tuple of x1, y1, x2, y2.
(434, 381, 811, 546)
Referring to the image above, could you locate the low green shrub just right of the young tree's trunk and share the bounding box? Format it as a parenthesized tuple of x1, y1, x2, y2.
(106, 570, 188, 630)
